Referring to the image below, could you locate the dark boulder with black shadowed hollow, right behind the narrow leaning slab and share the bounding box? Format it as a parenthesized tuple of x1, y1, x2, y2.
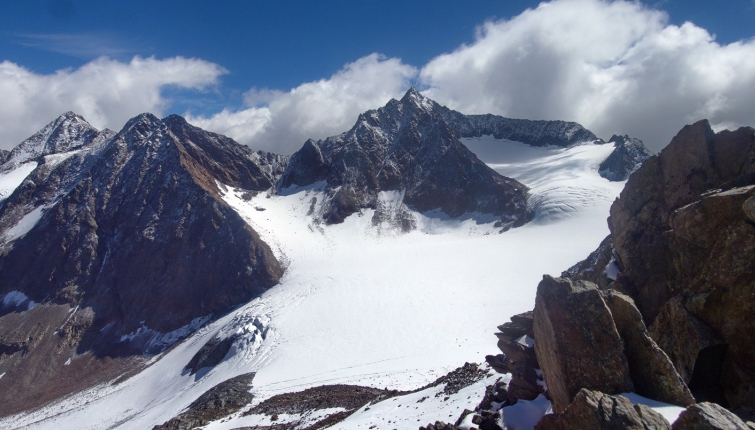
(650, 297, 728, 402)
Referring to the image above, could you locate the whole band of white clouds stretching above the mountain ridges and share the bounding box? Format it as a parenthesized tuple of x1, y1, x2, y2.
(0, 0, 755, 154)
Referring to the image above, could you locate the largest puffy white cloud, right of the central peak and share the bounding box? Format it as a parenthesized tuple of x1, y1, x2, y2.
(420, 0, 755, 151)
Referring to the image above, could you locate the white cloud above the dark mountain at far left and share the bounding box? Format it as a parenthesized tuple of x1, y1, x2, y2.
(0, 57, 226, 149)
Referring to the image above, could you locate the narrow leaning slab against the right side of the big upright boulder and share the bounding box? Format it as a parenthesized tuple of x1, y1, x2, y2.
(605, 290, 695, 406)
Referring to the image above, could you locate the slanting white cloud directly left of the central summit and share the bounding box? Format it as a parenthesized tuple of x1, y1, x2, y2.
(186, 54, 417, 154)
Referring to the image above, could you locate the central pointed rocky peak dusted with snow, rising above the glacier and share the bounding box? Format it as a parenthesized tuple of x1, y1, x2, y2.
(279, 89, 533, 228)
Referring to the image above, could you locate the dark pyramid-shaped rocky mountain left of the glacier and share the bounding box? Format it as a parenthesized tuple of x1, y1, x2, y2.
(0, 114, 285, 414)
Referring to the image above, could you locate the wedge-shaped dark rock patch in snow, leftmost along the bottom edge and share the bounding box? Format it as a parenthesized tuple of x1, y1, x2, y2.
(153, 373, 254, 430)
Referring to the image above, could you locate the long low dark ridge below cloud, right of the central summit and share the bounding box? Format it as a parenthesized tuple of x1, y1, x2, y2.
(438, 106, 603, 147)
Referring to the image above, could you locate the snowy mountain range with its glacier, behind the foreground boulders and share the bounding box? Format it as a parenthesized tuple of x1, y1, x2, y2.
(0, 89, 648, 428)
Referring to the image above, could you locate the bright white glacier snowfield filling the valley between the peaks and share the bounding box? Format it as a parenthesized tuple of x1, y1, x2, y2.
(0, 137, 656, 430)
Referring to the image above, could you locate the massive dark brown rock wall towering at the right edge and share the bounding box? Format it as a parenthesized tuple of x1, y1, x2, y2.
(609, 121, 755, 406)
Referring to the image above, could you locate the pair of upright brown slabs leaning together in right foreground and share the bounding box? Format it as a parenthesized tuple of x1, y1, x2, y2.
(534, 276, 695, 412)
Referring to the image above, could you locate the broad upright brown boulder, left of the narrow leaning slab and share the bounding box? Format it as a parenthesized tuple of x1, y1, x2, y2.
(534, 275, 634, 412)
